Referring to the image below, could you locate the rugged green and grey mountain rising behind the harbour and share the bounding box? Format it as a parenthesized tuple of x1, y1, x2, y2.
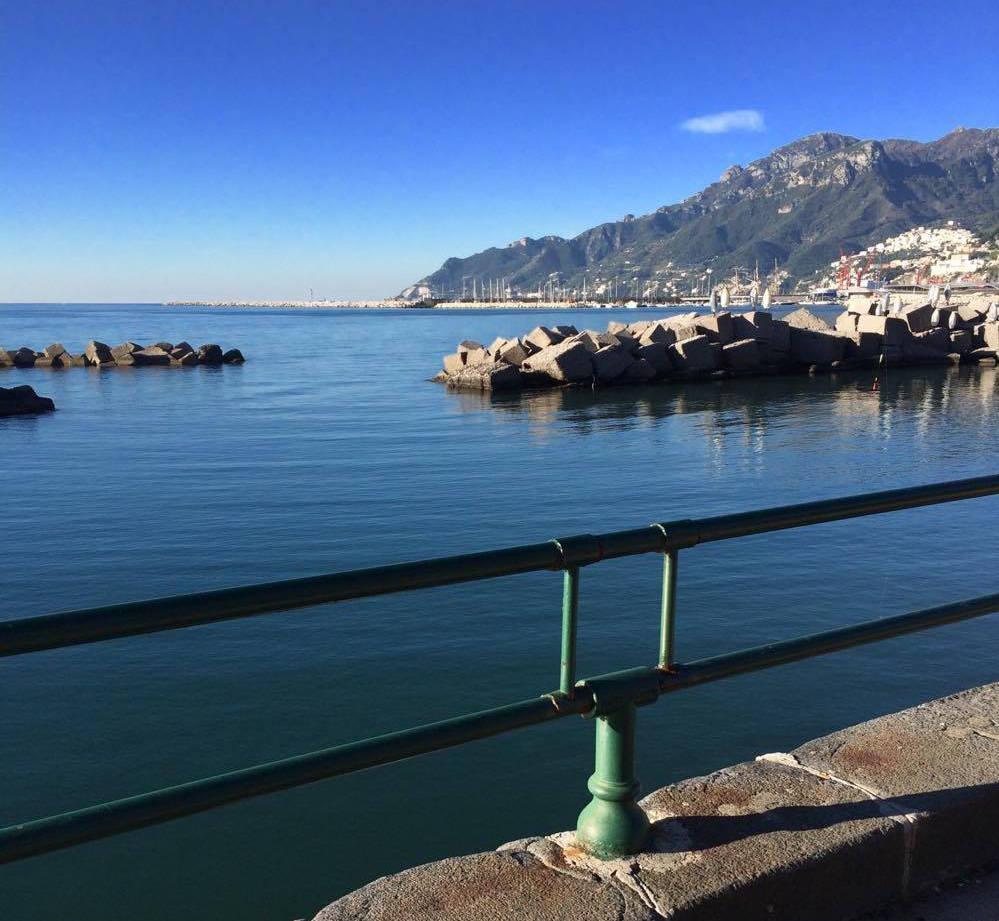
(404, 128, 999, 295)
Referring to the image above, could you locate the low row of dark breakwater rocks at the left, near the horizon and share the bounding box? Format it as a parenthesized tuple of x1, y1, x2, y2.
(0, 339, 246, 368)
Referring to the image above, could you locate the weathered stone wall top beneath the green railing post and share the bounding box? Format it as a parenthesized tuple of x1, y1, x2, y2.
(317, 684, 999, 921)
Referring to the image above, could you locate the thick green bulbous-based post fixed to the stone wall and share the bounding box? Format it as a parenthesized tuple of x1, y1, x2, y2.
(576, 703, 649, 860)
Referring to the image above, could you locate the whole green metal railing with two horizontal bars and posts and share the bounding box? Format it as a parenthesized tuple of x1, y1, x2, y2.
(0, 476, 999, 863)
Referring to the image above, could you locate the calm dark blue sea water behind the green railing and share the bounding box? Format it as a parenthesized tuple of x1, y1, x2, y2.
(0, 305, 999, 921)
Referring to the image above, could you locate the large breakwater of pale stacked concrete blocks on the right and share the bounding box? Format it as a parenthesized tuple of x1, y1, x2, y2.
(434, 297, 999, 391)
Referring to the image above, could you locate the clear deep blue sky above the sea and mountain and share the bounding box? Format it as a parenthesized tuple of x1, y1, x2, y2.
(0, 0, 999, 301)
